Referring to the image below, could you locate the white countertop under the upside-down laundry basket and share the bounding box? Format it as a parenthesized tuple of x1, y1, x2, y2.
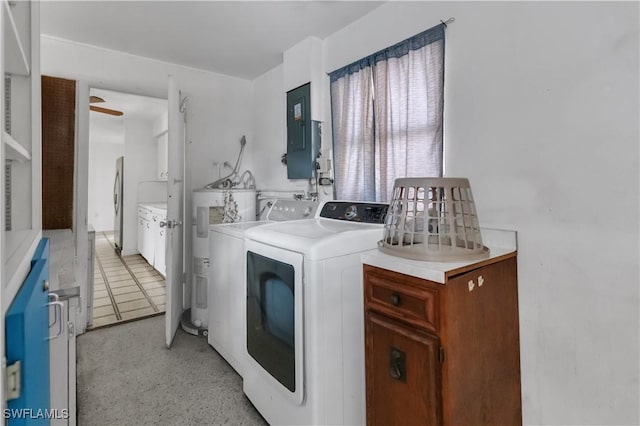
(362, 228, 518, 284)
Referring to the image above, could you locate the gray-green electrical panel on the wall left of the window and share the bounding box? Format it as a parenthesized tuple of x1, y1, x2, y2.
(287, 83, 321, 179)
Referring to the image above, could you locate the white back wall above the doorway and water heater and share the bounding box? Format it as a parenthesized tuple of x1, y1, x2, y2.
(41, 35, 253, 300)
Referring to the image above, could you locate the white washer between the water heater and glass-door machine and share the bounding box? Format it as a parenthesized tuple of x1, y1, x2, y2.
(207, 199, 318, 376)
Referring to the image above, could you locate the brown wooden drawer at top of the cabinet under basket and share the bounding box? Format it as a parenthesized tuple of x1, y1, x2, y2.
(364, 265, 439, 331)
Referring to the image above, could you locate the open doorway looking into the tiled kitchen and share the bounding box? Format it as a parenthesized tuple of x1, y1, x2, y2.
(87, 88, 167, 329)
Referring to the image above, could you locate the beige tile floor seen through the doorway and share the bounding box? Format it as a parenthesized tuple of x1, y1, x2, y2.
(90, 232, 165, 329)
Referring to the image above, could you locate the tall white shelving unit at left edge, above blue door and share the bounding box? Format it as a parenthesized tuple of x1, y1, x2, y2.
(0, 0, 42, 312)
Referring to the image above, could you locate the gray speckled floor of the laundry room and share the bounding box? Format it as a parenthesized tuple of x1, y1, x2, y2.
(77, 315, 267, 426)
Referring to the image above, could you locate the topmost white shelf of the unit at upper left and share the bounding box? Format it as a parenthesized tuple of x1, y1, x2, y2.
(2, 0, 30, 75)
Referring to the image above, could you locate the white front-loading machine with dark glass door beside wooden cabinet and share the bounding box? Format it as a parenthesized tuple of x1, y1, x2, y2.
(243, 201, 387, 425)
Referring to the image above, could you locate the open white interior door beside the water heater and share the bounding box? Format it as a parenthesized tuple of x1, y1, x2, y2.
(165, 76, 186, 348)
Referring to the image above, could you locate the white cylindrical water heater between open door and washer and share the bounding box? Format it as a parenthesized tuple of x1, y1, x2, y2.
(190, 189, 256, 334)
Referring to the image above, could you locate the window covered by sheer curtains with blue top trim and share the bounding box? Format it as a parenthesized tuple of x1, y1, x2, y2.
(330, 25, 445, 202)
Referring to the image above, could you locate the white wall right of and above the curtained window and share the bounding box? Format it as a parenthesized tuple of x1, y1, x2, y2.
(322, 2, 640, 425)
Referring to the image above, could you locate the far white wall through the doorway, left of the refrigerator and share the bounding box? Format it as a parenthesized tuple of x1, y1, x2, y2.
(87, 114, 125, 232)
